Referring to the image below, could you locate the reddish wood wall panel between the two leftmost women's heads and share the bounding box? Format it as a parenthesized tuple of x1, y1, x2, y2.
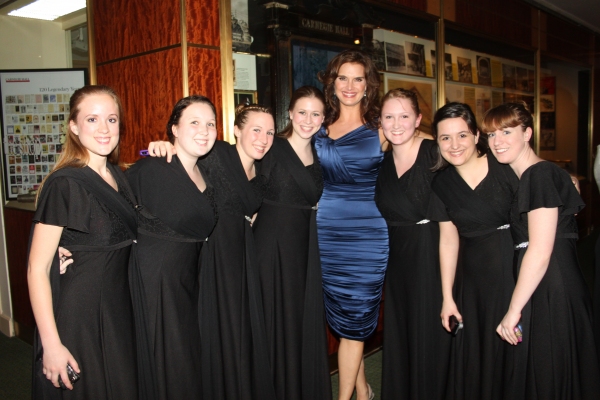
(98, 48, 183, 162)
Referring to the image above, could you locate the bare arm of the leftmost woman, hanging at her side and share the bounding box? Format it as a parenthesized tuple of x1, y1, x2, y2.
(27, 223, 81, 389)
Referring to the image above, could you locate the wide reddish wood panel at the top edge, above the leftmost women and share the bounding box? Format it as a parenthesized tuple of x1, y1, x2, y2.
(93, 0, 182, 63)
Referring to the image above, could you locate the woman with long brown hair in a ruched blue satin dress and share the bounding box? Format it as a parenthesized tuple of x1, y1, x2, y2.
(314, 50, 388, 400)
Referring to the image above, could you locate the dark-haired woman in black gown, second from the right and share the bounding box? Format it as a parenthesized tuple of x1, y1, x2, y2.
(432, 103, 518, 399)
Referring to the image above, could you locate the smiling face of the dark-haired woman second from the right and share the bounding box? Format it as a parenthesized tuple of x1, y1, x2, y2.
(437, 118, 479, 167)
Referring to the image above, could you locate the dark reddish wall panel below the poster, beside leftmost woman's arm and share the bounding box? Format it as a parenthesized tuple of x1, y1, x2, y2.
(4, 207, 35, 334)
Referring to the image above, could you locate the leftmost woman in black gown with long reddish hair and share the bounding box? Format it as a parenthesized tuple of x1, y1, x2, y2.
(27, 86, 138, 399)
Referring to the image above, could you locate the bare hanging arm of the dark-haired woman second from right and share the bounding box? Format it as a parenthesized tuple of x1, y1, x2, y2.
(439, 221, 462, 332)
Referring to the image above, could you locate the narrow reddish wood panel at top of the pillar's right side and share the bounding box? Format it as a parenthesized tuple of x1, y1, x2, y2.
(185, 0, 221, 47)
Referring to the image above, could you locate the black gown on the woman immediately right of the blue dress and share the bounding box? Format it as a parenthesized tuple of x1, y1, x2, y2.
(375, 140, 451, 400)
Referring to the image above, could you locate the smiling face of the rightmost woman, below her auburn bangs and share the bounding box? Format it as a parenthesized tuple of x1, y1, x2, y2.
(488, 125, 533, 164)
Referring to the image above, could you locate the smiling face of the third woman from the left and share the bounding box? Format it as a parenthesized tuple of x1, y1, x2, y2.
(234, 111, 275, 161)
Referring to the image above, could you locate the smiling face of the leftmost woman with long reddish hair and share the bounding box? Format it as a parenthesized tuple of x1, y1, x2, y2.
(69, 94, 120, 163)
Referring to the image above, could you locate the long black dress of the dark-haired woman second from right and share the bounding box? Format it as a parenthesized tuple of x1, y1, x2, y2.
(432, 154, 521, 399)
